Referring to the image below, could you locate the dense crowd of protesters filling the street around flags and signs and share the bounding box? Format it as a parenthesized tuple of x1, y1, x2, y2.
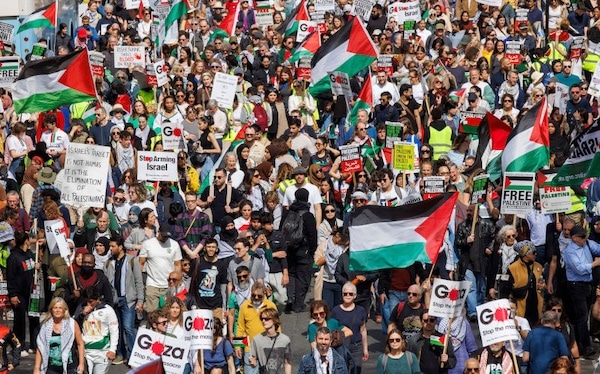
(0, 0, 600, 374)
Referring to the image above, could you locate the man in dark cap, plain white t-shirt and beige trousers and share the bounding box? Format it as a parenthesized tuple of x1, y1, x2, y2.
(139, 223, 181, 313)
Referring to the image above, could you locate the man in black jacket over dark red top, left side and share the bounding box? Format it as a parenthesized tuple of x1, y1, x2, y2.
(65, 253, 113, 315)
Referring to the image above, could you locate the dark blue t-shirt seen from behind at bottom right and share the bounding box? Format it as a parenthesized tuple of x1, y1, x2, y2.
(523, 326, 569, 374)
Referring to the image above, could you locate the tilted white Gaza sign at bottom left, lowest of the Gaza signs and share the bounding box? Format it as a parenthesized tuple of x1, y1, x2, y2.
(128, 327, 190, 374)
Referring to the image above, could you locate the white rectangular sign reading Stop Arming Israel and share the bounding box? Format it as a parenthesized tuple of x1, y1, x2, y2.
(137, 151, 177, 182)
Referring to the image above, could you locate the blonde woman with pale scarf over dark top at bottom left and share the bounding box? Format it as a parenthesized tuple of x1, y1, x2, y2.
(33, 297, 85, 374)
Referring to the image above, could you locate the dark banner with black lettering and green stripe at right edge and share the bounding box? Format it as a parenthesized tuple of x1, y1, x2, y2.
(552, 121, 600, 186)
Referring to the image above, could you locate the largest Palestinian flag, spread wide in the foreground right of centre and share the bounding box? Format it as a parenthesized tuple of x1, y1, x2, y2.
(350, 193, 458, 271)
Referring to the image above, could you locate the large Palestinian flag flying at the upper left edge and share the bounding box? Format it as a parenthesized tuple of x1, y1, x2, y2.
(13, 49, 96, 113)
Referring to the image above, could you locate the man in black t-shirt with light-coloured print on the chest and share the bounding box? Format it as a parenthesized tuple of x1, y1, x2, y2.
(190, 239, 227, 319)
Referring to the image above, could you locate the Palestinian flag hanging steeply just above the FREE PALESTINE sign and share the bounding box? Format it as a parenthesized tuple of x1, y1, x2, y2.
(502, 98, 550, 172)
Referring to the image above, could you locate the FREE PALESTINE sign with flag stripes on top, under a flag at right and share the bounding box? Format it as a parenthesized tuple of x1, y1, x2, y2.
(501, 172, 535, 214)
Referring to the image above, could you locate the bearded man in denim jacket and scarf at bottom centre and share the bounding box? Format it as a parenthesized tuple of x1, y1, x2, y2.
(298, 326, 348, 374)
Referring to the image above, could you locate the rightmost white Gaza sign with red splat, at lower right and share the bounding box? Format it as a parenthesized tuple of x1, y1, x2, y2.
(477, 299, 520, 347)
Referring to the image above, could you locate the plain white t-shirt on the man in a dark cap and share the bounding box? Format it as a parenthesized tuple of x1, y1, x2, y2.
(139, 238, 181, 288)
